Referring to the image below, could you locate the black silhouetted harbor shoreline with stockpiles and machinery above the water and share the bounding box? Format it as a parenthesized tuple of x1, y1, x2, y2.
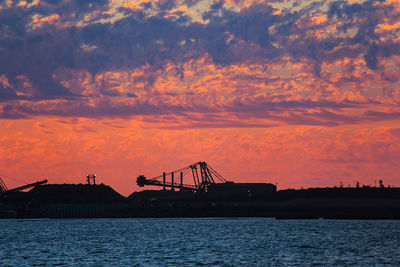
(0, 162, 400, 219)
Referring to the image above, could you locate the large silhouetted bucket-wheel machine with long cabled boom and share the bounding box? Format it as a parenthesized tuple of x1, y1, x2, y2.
(136, 161, 229, 192)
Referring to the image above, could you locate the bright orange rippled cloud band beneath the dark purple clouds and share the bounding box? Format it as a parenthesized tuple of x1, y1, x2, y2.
(3, 52, 398, 128)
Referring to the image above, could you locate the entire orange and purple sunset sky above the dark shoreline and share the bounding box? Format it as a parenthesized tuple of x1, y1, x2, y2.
(0, 0, 400, 196)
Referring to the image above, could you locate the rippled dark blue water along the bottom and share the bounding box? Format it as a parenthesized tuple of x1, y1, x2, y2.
(0, 218, 400, 266)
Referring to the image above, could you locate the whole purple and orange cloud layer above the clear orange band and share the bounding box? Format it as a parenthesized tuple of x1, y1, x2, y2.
(0, 0, 400, 128)
